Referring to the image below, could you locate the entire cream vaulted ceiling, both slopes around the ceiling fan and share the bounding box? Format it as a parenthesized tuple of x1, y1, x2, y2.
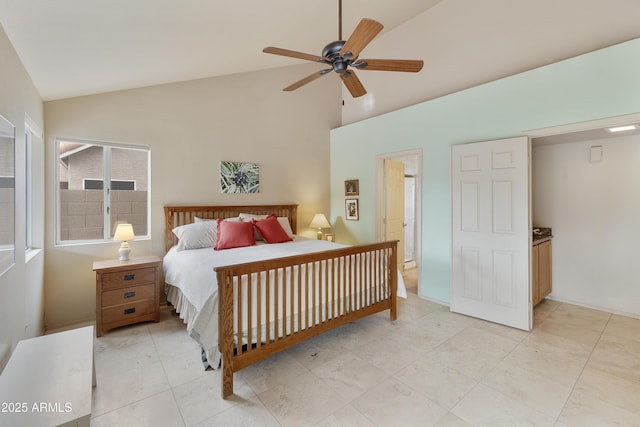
(0, 0, 640, 128)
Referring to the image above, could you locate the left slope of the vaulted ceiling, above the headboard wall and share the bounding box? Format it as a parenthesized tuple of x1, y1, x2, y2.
(0, 0, 442, 100)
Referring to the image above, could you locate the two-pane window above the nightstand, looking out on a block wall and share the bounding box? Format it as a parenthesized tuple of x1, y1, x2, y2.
(56, 139, 151, 244)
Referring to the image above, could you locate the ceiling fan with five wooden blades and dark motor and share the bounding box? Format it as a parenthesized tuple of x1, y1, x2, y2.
(262, 0, 424, 98)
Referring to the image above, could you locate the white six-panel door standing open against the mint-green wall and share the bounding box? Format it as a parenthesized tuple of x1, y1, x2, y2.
(451, 137, 532, 331)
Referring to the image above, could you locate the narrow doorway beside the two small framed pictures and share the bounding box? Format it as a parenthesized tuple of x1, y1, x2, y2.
(377, 149, 422, 295)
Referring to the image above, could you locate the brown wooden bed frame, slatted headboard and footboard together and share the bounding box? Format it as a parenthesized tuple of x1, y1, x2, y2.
(164, 205, 398, 399)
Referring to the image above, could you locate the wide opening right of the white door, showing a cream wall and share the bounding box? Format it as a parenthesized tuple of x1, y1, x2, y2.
(528, 114, 640, 321)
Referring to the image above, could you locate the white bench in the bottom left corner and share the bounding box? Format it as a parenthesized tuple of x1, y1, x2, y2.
(0, 326, 96, 427)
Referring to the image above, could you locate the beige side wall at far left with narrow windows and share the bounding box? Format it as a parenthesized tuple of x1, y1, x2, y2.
(0, 26, 44, 369)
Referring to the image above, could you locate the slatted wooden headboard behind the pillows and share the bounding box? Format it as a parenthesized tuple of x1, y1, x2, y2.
(164, 205, 298, 251)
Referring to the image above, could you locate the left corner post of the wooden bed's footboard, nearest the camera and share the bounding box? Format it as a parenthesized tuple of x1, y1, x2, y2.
(217, 272, 233, 399)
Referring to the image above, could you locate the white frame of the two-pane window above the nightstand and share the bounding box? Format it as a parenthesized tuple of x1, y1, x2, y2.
(54, 137, 151, 246)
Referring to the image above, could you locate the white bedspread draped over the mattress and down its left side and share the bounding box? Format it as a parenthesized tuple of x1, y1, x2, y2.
(163, 236, 407, 369)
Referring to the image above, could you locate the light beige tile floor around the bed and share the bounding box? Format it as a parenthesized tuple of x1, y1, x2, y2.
(91, 294, 640, 427)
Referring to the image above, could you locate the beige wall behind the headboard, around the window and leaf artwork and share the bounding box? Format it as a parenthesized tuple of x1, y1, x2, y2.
(45, 64, 341, 329)
